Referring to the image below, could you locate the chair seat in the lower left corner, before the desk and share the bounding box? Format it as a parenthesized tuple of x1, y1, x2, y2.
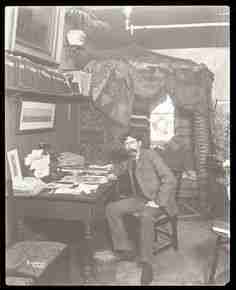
(6, 241, 67, 278)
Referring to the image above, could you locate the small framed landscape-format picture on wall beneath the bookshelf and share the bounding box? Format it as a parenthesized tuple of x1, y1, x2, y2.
(17, 100, 56, 134)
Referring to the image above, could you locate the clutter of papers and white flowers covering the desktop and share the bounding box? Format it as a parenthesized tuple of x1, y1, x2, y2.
(8, 149, 116, 198)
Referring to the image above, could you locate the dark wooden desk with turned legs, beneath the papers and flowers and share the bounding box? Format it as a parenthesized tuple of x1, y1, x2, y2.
(13, 182, 113, 283)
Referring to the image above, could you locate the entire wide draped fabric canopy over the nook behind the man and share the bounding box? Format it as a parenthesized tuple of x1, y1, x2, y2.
(84, 46, 213, 126)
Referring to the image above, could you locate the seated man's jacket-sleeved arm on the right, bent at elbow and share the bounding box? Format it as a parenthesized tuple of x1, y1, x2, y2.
(149, 150, 177, 207)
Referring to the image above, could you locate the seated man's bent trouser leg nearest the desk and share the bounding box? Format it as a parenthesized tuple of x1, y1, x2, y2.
(106, 198, 145, 250)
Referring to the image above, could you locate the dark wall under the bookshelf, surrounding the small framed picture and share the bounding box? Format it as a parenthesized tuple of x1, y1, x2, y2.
(5, 96, 79, 176)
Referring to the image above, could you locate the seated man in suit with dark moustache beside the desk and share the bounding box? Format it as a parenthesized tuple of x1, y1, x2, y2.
(106, 136, 177, 285)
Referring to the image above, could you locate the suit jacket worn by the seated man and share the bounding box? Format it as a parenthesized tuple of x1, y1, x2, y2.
(128, 149, 177, 215)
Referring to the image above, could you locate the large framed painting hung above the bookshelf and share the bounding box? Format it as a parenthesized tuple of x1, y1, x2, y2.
(5, 6, 64, 64)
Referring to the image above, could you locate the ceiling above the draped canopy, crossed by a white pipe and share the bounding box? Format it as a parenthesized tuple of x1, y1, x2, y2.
(80, 5, 229, 49)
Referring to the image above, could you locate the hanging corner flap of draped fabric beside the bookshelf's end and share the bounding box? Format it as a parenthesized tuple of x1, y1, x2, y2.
(85, 60, 134, 126)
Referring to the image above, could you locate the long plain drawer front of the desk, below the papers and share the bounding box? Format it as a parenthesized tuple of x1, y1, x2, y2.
(16, 199, 93, 220)
